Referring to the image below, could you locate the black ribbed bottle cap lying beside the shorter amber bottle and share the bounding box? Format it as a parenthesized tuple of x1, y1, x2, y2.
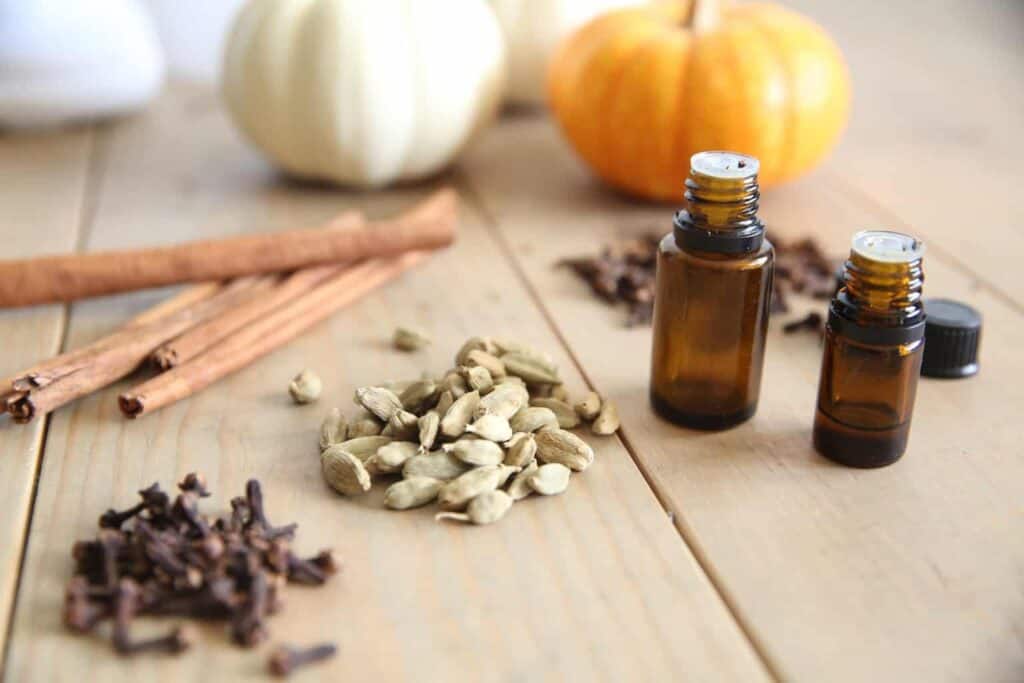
(921, 299, 981, 379)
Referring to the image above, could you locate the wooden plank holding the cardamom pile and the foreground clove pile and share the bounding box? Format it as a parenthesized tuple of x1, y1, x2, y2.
(8, 85, 765, 681)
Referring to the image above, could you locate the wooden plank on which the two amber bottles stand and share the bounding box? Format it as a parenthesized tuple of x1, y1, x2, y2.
(465, 118, 1024, 681)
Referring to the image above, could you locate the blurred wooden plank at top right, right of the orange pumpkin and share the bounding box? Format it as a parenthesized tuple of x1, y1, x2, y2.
(792, 0, 1024, 310)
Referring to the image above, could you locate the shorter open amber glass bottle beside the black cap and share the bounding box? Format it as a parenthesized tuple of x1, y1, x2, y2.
(814, 230, 925, 467)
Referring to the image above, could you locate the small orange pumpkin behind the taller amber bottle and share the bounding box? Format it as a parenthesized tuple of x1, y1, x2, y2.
(548, 0, 850, 201)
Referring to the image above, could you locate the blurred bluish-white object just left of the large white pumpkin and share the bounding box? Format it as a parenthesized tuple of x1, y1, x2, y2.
(144, 0, 245, 83)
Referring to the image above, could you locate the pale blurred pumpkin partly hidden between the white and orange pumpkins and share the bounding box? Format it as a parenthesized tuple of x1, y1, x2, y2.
(490, 0, 644, 104)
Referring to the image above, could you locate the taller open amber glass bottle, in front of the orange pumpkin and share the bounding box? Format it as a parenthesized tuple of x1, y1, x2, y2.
(650, 152, 774, 429)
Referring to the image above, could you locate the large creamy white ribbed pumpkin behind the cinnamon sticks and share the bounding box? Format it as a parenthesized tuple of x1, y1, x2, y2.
(223, 0, 505, 186)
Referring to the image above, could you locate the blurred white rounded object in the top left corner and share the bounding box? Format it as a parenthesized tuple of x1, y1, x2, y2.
(0, 0, 164, 128)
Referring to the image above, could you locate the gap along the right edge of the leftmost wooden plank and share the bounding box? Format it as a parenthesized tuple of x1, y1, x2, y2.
(0, 124, 111, 678)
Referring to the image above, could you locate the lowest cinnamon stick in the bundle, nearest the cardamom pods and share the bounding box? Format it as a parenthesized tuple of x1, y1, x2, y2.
(118, 252, 426, 418)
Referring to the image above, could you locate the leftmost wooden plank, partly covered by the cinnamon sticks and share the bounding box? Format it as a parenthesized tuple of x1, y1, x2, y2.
(0, 129, 93, 649)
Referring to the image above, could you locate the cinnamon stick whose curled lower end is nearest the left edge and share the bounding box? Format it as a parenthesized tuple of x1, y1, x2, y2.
(5, 278, 275, 422)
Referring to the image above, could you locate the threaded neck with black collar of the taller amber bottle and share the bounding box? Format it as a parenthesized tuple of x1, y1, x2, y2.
(675, 171, 765, 255)
